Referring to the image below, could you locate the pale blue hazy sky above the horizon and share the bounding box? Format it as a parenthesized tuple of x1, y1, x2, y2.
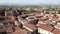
(0, 0, 60, 5)
